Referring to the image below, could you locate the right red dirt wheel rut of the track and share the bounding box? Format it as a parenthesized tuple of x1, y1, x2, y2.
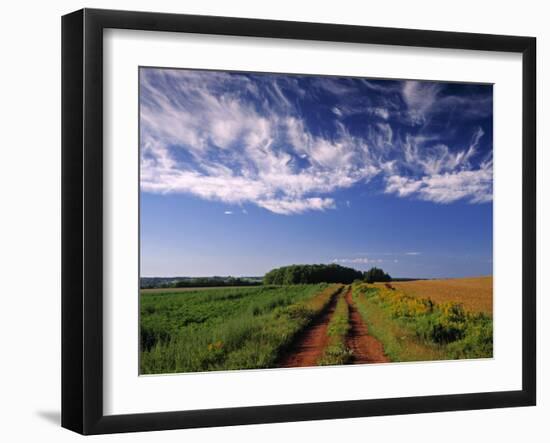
(346, 288, 390, 364)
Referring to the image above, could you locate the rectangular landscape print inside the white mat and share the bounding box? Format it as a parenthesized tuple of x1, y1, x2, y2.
(139, 67, 496, 375)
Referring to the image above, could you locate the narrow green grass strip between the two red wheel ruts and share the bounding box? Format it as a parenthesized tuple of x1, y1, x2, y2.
(319, 288, 352, 365)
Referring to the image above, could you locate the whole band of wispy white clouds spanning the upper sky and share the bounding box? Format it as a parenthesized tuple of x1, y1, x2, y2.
(140, 69, 492, 215)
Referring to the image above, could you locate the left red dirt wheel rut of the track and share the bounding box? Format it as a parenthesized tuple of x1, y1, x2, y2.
(277, 292, 341, 368)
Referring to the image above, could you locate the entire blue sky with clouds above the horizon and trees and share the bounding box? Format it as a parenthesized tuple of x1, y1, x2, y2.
(140, 68, 493, 278)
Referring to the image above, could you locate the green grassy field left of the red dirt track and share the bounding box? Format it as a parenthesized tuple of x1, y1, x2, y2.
(140, 284, 341, 374)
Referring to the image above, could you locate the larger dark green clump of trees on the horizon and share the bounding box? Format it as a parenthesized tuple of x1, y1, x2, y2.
(264, 264, 363, 285)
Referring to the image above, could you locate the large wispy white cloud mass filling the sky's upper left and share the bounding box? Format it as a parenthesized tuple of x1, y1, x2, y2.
(140, 70, 384, 214)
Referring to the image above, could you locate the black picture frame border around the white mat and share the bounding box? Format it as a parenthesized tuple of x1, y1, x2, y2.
(62, 9, 536, 434)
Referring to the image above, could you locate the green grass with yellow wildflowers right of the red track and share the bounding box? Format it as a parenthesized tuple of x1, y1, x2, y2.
(353, 285, 493, 362)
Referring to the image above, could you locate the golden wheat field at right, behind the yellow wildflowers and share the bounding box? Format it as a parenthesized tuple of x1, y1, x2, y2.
(384, 276, 493, 315)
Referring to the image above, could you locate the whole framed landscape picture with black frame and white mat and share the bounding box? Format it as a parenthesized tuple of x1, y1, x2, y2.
(62, 9, 536, 434)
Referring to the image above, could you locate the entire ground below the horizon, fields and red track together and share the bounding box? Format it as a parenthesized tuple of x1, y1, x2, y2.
(140, 277, 493, 374)
